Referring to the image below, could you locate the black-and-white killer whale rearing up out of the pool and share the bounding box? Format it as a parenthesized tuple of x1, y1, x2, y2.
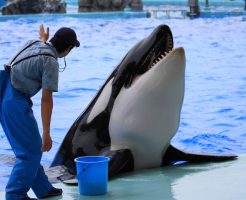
(51, 25, 236, 178)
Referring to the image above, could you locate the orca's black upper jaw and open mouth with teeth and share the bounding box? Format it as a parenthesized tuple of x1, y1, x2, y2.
(112, 25, 173, 88)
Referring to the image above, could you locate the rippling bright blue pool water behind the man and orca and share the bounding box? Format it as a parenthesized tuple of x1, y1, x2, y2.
(0, 15, 246, 191)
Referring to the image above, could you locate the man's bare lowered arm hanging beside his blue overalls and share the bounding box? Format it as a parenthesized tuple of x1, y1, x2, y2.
(41, 89, 53, 152)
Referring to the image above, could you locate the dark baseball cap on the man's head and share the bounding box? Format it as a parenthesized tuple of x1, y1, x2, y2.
(54, 27, 80, 47)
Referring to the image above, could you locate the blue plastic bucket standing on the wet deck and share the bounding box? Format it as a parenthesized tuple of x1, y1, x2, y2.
(74, 156, 109, 195)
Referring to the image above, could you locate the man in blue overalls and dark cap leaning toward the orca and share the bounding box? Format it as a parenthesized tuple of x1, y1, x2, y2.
(0, 25, 80, 200)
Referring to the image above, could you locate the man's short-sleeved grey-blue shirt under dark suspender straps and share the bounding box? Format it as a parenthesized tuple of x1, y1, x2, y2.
(11, 40, 59, 97)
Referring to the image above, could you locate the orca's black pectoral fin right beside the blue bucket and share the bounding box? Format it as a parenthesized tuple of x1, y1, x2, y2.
(99, 149, 134, 178)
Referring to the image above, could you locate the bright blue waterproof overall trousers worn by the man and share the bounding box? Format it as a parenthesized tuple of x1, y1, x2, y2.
(0, 39, 58, 200)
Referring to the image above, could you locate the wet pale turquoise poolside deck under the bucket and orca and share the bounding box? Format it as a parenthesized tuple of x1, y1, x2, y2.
(0, 155, 246, 200)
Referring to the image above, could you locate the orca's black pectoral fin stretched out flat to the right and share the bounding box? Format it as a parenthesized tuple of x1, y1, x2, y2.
(162, 145, 237, 166)
